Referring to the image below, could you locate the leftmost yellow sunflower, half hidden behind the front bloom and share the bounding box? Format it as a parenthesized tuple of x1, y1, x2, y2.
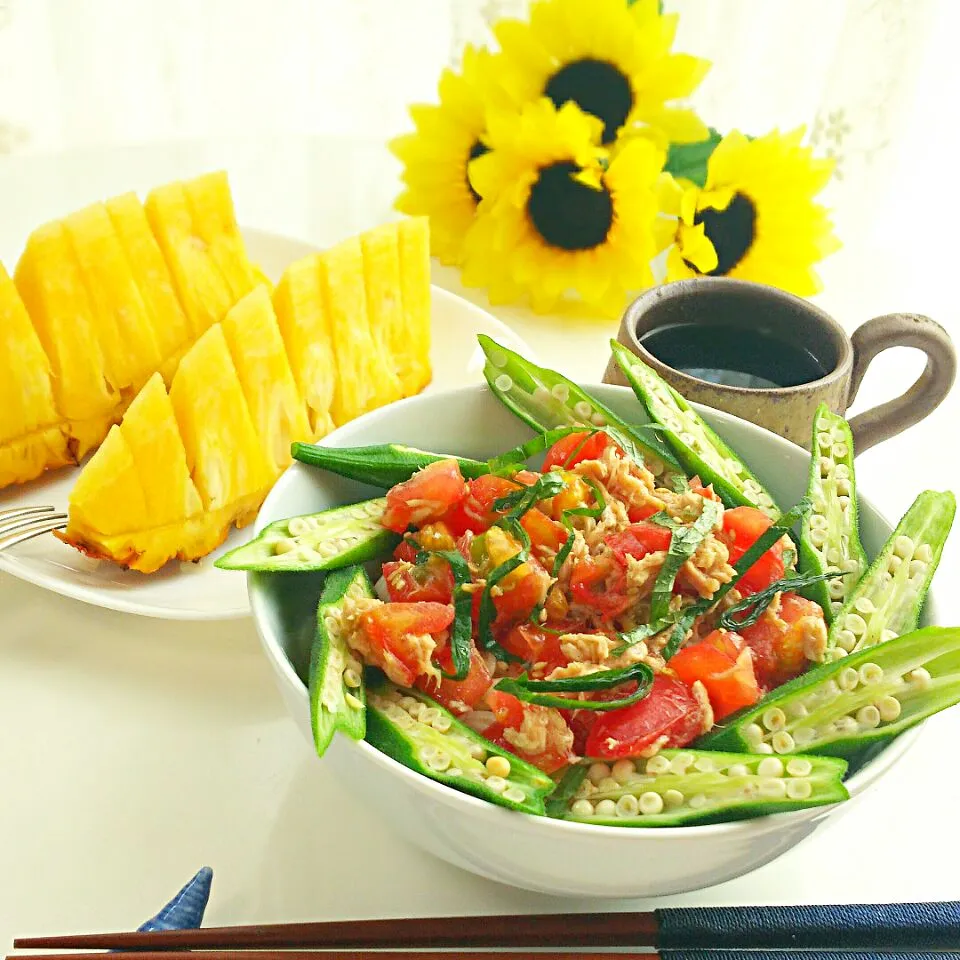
(390, 46, 491, 265)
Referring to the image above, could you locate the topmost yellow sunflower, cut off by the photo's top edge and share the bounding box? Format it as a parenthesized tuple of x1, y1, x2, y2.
(491, 0, 710, 145)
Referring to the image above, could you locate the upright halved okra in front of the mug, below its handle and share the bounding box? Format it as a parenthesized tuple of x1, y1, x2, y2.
(800, 403, 868, 623)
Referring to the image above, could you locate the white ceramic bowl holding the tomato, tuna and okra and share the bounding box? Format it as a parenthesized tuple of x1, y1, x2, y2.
(249, 385, 936, 898)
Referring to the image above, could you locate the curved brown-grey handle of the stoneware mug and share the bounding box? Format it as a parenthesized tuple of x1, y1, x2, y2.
(847, 313, 957, 453)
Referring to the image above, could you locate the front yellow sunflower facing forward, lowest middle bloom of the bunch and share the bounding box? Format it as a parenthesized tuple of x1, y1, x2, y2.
(463, 97, 664, 316)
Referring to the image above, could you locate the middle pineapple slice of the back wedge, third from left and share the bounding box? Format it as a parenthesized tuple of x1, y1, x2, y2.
(106, 193, 192, 383)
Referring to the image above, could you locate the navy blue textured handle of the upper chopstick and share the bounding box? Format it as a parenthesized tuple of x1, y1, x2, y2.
(655, 902, 960, 960)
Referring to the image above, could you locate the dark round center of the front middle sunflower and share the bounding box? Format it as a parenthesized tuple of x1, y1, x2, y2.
(527, 161, 613, 250)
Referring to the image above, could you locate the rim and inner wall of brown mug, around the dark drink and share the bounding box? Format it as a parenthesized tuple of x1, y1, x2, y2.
(624, 277, 853, 397)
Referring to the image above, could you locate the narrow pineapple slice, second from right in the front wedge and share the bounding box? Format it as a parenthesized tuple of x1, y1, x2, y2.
(360, 223, 409, 396)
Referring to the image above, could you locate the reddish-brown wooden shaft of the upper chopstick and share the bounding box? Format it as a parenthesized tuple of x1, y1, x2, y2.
(13, 913, 660, 960)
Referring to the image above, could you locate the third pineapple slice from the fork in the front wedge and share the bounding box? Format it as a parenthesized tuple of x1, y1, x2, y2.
(170, 324, 274, 526)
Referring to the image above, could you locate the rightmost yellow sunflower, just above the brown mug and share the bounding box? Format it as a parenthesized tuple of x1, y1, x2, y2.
(657, 127, 840, 297)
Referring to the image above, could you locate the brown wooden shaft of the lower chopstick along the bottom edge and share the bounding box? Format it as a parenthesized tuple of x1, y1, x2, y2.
(7, 950, 659, 960)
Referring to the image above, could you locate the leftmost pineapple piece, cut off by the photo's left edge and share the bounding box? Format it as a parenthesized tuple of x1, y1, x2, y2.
(0, 264, 73, 488)
